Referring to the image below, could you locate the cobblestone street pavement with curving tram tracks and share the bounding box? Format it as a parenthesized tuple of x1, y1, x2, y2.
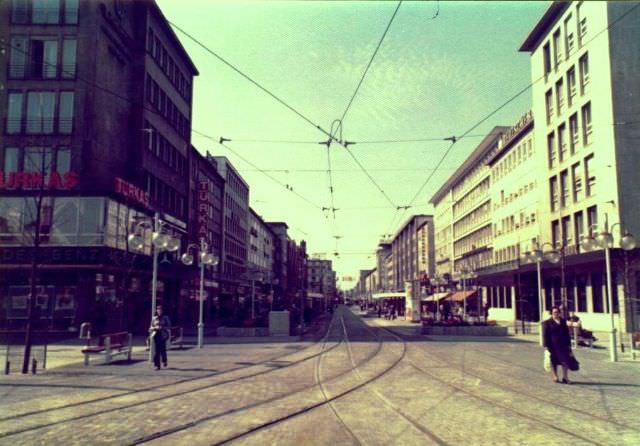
(0, 307, 640, 446)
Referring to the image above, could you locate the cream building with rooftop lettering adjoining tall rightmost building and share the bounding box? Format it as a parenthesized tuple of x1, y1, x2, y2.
(475, 112, 544, 321)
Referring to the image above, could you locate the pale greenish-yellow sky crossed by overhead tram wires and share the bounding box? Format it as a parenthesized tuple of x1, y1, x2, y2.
(157, 0, 550, 289)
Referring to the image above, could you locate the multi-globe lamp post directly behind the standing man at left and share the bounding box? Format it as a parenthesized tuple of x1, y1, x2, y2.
(127, 212, 180, 362)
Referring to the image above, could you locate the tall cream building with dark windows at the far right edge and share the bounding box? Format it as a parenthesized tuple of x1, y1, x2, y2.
(520, 1, 640, 330)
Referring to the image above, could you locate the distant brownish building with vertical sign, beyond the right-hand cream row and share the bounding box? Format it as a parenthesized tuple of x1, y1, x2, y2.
(391, 215, 435, 291)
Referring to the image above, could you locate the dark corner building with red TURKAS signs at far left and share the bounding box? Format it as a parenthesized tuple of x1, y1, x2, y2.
(0, 0, 198, 332)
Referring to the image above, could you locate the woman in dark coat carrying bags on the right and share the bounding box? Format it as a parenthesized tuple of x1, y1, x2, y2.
(542, 306, 575, 384)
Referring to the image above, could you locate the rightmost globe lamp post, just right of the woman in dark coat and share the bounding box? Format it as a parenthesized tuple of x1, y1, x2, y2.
(582, 214, 636, 362)
